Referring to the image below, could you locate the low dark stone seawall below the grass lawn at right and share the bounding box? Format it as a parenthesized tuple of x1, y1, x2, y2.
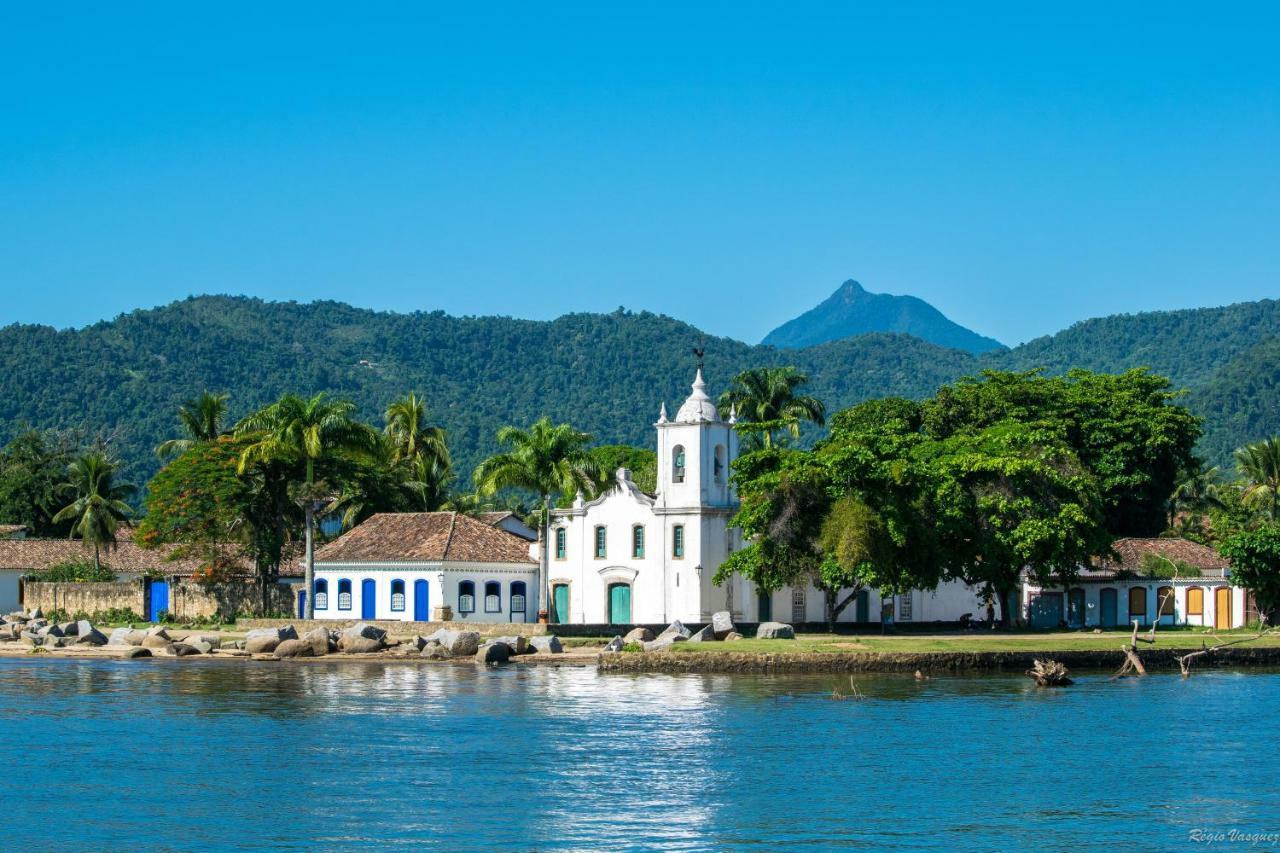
(599, 646, 1280, 674)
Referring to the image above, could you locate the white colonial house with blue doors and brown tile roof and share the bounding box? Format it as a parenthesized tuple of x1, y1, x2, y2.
(307, 512, 538, 622)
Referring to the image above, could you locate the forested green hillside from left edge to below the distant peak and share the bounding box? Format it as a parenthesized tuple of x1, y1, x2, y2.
(0, 297, 972, 483)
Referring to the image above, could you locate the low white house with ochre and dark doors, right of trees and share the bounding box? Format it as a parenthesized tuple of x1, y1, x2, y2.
(1020, 538, 1256, 629)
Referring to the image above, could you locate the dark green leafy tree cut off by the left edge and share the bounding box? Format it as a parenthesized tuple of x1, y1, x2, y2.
(0, 429, 76, 537)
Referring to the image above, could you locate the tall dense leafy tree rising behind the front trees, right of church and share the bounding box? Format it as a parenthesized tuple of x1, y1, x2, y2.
(923, 370, 1201, 537)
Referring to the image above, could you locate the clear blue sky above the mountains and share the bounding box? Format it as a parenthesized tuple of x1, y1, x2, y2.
(0, 3, 1280, 343)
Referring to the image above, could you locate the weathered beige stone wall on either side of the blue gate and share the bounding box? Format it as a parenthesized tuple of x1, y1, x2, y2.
(22, 580, 294, 620)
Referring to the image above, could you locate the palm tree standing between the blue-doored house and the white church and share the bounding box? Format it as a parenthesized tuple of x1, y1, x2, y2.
(475, 418, 600, 621)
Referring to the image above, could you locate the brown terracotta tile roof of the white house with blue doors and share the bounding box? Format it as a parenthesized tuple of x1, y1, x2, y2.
(316, 512, 534, 564)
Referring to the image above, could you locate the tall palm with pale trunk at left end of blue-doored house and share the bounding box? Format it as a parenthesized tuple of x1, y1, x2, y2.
(236, 392, 383, 619)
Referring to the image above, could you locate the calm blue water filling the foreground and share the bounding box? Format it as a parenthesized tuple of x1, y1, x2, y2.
(0, 660, 1280, 850)
